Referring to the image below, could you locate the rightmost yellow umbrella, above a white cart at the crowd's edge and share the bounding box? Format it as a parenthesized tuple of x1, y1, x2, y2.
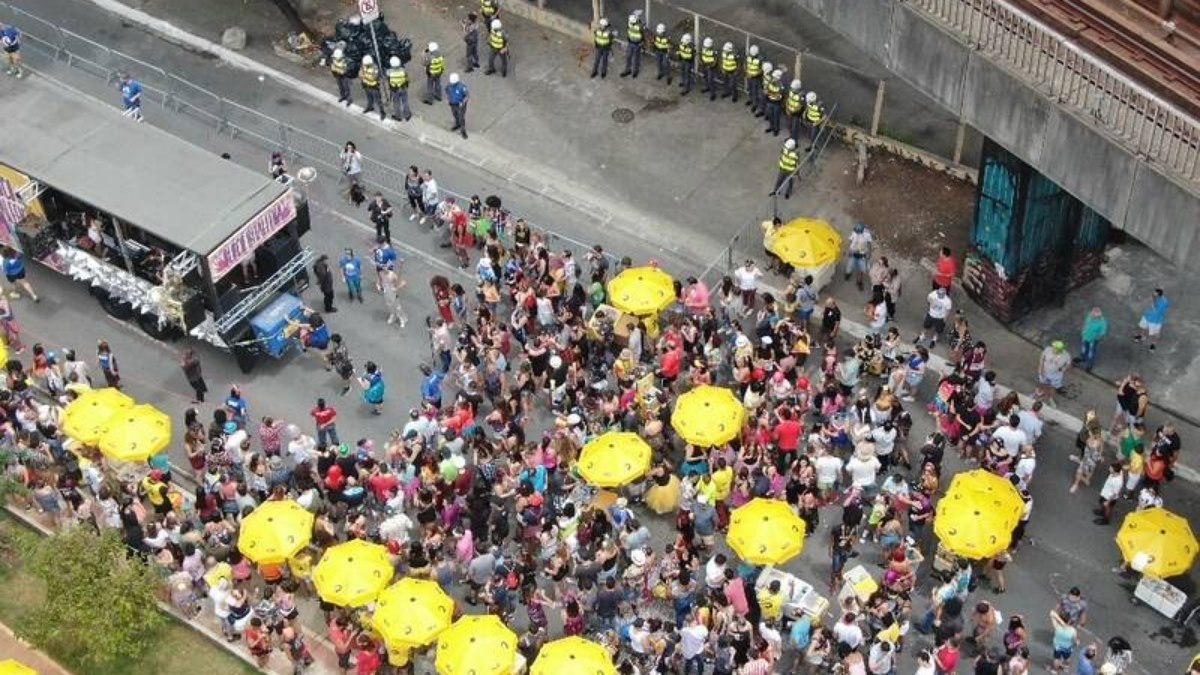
(1117, 507, 1200, 579)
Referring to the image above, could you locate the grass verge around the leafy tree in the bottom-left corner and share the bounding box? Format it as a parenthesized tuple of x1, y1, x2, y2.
(0, 510, 258, 675)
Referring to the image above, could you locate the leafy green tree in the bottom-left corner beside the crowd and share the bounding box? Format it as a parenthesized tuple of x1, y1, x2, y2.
(23, 526, 164, 665)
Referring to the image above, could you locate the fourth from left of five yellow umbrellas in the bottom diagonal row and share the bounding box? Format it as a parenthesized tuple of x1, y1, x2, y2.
(434, 614, 517, 675)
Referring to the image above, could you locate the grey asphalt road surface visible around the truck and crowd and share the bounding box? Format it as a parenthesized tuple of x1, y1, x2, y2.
(0, 0, 1200, 673)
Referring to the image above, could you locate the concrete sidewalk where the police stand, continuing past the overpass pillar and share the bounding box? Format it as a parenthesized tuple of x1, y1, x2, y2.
(72, 0, 1200, 478)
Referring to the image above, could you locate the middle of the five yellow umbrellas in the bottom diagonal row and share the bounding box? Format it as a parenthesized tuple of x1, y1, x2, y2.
(372, 578, 454, 647)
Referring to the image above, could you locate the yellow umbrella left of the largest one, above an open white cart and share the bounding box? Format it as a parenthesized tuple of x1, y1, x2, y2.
(725, 497, 805, 565)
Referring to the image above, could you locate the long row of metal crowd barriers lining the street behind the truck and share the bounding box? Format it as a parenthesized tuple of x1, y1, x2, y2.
(0, 1, 620, 270)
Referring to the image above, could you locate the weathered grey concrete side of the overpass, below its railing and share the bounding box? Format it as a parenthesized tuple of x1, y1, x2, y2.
(793, 0, 1200, 271)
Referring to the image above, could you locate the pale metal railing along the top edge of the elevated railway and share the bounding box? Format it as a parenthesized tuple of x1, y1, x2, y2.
(910, 0, 1200, 185)
